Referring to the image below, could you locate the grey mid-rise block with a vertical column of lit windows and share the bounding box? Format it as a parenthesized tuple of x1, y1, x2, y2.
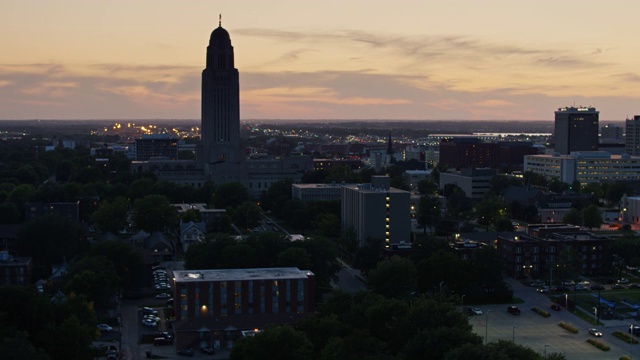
(341, 176, 411, 248)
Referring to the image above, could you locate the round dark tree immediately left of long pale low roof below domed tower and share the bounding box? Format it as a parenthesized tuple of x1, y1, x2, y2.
(133, 195, 178, 233)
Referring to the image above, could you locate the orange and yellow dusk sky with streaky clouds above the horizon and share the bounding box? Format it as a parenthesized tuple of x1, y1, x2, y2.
(0, 0, 640, 121)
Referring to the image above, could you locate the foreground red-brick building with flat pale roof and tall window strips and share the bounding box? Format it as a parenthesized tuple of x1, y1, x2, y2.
(173, 268, 315, 349)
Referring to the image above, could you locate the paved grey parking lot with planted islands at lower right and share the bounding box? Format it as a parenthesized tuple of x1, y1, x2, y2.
(469, 281, 640, 360)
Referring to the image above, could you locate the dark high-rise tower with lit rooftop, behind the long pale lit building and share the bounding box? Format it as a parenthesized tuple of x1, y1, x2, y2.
(554, 107, 600, 155)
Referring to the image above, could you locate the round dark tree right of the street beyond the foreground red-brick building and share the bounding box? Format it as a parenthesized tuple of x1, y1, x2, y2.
(367, 256, 416, 298)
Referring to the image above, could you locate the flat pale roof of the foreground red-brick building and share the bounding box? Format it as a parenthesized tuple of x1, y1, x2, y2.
(173, 267, 313, 282)
